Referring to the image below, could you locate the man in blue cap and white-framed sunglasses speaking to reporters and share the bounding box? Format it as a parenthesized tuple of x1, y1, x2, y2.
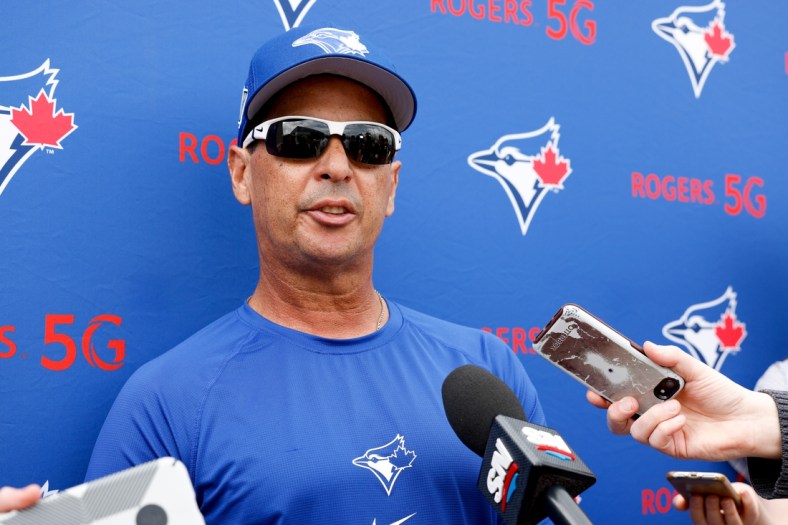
(87, 28, 545, 525)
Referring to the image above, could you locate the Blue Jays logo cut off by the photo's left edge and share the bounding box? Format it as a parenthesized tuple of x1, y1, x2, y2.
(0, 60, 77, 198)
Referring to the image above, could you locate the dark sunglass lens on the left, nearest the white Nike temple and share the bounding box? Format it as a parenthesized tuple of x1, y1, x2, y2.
(265, 120, 328, 159)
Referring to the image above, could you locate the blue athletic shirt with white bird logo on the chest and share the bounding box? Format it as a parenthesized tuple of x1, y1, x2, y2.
(86, 301, 545, 525)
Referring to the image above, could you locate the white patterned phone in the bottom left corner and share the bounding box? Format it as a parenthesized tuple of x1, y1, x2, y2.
(0, 457, 205, 525)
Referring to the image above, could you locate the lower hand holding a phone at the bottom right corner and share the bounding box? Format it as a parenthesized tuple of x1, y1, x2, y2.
(673, 483, 788, 525)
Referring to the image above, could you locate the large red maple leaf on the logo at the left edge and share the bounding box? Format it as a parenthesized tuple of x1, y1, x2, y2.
(11, 89, 77, 149)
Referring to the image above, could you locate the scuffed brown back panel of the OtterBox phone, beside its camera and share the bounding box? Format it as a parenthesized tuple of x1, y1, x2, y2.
(542, 311, 662, 401)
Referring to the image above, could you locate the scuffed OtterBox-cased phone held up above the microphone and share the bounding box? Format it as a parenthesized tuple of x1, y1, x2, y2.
(534, 304, 684, 414)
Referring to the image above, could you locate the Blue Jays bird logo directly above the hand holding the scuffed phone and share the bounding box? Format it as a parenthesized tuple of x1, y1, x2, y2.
(662, 286, 747, 370)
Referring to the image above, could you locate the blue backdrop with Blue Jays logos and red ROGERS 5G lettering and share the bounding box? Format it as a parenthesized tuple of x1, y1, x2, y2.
(0, 0, 788, 524)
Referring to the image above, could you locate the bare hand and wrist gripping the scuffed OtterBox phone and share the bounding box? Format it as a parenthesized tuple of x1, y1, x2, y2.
(587, 342, 783, 461)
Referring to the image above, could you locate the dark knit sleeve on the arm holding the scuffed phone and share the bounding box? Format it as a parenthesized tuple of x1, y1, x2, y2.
(747, 390, 788, 499)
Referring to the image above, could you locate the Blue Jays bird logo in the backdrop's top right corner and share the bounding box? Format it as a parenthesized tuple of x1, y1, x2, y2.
(651, 0, 736, 98)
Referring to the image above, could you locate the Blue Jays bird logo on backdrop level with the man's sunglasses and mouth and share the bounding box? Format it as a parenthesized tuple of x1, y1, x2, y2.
(468, 118, 572, 235)
